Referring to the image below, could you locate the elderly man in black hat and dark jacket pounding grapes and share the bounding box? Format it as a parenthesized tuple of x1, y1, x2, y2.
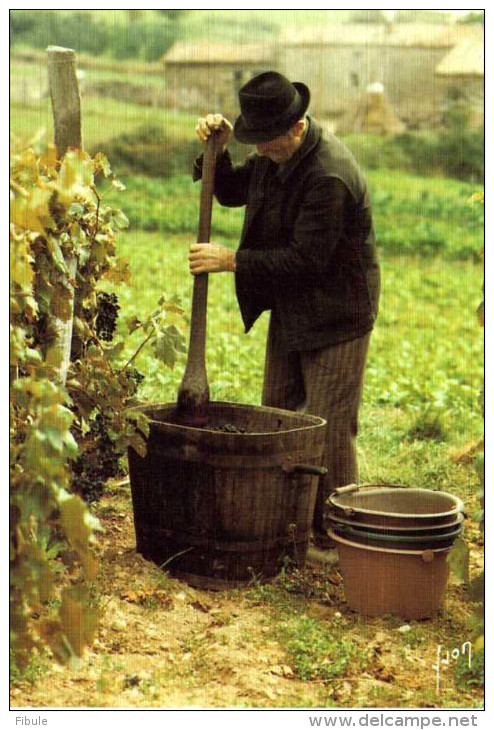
(189, 71, 379, 548)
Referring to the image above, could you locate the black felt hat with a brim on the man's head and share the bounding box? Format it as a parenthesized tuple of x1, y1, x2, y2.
(233, 71, 310, 144)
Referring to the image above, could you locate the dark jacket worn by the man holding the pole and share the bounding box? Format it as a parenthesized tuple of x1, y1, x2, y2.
(194, 120, 379, 351)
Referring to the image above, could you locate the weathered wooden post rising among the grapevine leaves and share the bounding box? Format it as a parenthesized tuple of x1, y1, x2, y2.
(46, 46, 82, 385)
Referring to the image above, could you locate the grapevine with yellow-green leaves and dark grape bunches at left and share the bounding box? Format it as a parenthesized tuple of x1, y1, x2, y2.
(10, 148, 184, 667)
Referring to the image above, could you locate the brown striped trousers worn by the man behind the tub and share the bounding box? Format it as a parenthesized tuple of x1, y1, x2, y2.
(262, 320, 370, 532)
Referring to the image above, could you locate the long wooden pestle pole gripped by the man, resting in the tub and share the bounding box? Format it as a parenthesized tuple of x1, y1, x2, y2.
(176, 133, 217, 427)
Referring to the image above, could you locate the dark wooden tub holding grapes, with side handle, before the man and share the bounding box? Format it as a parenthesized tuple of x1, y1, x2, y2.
(129, 403, 326, 589)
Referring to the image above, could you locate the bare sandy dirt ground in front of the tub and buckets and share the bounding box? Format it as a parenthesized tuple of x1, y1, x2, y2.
(11, 484, 483, 708)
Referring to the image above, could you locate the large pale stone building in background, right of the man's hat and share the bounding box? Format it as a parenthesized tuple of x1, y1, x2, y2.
(278, 23, 484, 129)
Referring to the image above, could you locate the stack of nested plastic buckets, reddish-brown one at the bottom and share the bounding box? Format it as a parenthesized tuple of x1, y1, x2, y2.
(328, 485, 464, 619)
